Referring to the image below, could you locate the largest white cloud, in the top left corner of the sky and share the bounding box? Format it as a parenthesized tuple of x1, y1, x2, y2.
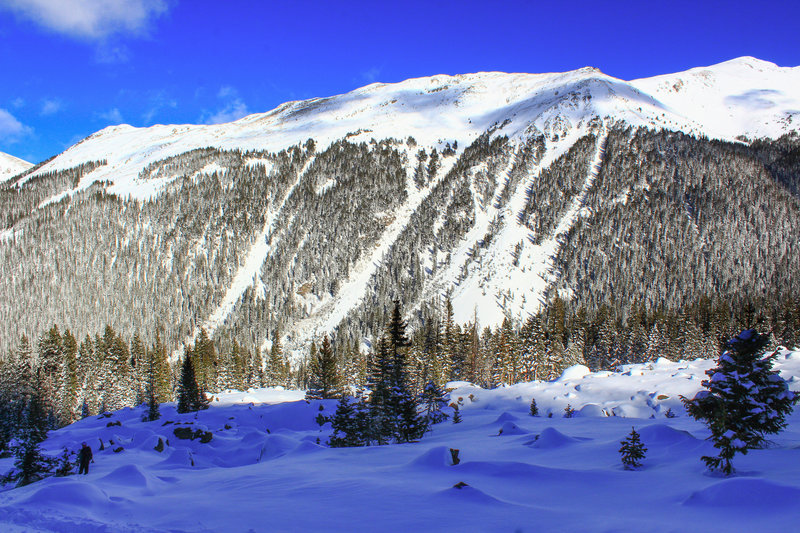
(2, 0, 169, 40)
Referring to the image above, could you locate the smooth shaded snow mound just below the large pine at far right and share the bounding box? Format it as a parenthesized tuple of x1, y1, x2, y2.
(683, 478, 800, 509)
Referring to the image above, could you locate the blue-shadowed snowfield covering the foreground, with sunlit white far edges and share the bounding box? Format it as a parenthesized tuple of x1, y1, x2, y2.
(0, 352, 800, 532)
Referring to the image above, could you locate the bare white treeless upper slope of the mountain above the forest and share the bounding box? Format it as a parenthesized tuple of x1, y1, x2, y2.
(23, 58, 800, 202)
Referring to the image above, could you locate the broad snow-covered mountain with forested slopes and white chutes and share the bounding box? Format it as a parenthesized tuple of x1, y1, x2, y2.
(0, 58, 800, 358)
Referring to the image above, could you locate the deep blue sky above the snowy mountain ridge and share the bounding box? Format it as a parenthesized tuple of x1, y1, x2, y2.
(0, 0, 800, 162)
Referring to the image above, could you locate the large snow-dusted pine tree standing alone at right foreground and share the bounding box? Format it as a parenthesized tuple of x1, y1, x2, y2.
(682, 329, 798, 475)
